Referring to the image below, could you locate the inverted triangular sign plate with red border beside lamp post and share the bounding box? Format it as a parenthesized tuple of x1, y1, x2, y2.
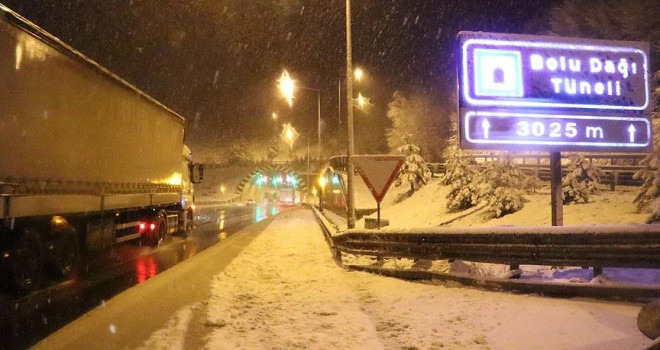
(351, 155, 406, 203)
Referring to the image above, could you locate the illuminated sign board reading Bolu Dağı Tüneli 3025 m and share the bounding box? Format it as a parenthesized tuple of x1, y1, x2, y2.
(458, 32, 653, 152)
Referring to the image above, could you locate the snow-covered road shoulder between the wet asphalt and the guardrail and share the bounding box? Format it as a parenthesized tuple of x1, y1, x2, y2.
(137, 209, 651, 349)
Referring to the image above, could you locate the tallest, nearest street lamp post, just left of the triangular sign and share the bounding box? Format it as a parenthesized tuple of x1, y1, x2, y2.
(346, 0, 355, 228)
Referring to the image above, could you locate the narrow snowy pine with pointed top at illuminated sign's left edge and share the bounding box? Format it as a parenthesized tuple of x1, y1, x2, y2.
(442, 123, 479, 210)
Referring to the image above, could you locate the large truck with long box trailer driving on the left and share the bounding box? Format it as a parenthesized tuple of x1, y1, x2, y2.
(0, 4, 202, 293)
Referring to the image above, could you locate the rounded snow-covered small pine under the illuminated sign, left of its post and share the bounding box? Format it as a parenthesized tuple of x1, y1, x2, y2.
(477, 153, 527, 218)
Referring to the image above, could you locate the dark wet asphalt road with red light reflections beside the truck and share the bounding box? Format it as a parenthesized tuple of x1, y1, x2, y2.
(0, 205, 279, 349)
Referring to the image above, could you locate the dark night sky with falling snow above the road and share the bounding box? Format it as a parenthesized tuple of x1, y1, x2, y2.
(0, 0, 558, 151)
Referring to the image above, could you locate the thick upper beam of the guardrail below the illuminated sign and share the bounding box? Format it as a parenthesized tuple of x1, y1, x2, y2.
(333, 225, 660, 268)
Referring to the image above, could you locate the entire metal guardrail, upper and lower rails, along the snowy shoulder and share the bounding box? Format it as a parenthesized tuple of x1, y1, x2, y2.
(324, 224, 660, 300)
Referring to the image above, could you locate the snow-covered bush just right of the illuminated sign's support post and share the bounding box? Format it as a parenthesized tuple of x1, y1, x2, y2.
(562, 154, 603, 204)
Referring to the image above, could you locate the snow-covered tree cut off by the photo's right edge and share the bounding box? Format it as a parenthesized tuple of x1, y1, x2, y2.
(633, 71, 660, 223)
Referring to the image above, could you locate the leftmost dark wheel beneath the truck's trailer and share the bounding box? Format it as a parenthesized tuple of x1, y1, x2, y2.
(11, 230, 44, 295)
